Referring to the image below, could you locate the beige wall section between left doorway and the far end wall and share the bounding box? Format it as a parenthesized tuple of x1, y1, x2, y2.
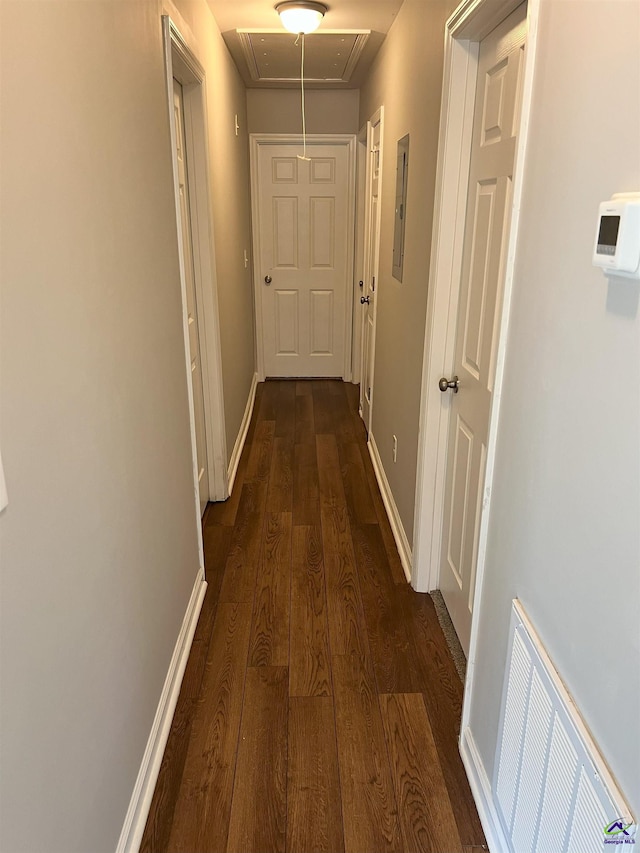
(169, 0, 255, 461)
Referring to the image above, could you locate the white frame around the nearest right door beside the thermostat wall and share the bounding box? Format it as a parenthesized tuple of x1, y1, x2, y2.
(412, 0, 540, 600)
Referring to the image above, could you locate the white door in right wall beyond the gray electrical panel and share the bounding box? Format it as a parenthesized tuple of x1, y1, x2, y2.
(360, 110, 382, 432)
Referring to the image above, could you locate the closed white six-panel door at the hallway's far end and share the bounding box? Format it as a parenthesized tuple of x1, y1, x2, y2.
(254, 142, 355, 377)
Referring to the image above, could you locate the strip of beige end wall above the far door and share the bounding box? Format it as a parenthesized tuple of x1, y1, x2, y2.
(247, 89, 359, 133)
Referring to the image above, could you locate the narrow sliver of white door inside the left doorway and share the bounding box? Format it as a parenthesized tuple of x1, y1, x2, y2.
(173, 79, 209, 515)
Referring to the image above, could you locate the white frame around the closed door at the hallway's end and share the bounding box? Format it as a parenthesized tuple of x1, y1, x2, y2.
(249, 133, 356, 382)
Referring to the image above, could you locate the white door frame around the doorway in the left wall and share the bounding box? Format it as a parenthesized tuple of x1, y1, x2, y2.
(162, 20, 229, 512)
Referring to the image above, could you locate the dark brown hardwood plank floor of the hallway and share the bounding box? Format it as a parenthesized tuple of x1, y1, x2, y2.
(141, 380, 485, 853)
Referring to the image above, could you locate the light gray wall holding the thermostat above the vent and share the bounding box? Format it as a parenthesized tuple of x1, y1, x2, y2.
(470, 0, 640, 815)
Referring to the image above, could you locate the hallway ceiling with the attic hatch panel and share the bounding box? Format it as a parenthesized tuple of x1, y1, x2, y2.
(208, 0, 403, 89)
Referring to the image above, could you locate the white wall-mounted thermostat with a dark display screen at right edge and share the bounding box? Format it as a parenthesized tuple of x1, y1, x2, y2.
(593, 193, 640, 279)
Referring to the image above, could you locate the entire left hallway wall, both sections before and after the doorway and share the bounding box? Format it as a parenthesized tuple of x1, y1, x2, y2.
(0, 0, 253, 853)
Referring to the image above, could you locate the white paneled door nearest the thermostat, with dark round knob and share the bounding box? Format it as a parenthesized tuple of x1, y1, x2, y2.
(440, 4, 526, 653)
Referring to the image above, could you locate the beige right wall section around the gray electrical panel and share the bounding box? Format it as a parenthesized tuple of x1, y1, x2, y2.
(360, 0, 451, 542)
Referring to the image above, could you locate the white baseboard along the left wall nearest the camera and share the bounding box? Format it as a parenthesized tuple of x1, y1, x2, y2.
(116, 570, 207, 853)
